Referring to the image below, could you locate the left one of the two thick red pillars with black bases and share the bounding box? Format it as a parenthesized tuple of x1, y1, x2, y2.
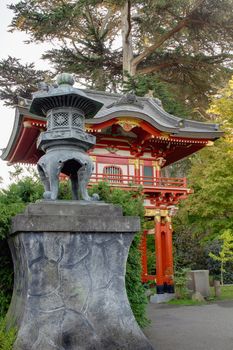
(155, 212, 164, 294)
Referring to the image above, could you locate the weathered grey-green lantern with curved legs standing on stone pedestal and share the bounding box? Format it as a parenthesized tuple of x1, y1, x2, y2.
(30, 73, 103, 201)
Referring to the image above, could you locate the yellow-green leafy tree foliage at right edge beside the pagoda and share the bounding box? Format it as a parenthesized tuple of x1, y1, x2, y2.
(176, 79, 233, 246)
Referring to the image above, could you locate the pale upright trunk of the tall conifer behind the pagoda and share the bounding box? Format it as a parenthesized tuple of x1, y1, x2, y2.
(121, 0, 136, 81)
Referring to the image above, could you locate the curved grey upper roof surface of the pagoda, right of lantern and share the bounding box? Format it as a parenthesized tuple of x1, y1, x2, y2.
(85, 90, 223, 140)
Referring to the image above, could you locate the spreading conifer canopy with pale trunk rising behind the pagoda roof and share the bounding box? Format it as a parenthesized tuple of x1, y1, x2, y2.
(0, 0, 233, 114)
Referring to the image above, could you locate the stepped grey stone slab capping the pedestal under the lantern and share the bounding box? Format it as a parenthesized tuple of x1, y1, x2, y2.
(10, 201, 140, 234)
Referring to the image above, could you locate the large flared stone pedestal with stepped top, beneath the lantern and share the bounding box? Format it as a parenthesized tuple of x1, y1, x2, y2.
(8, 201, 153, 350)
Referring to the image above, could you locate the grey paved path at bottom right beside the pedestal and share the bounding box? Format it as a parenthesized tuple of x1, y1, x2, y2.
(145, 301, 233, 350)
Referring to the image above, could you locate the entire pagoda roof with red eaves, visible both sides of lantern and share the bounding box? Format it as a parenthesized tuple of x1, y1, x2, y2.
(1, 90, 223, 164)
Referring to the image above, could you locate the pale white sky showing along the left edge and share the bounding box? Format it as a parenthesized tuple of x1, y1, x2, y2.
(0, 0, 49, 187)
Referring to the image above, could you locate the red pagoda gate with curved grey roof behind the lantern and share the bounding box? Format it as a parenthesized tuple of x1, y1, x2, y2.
(2, 90, 222, 294)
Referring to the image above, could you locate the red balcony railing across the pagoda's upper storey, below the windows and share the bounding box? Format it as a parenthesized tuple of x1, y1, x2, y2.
(90, 173, 187, 188)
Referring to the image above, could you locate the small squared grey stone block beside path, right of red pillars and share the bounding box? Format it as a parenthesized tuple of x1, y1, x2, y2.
(188, 270, 210, 297)
